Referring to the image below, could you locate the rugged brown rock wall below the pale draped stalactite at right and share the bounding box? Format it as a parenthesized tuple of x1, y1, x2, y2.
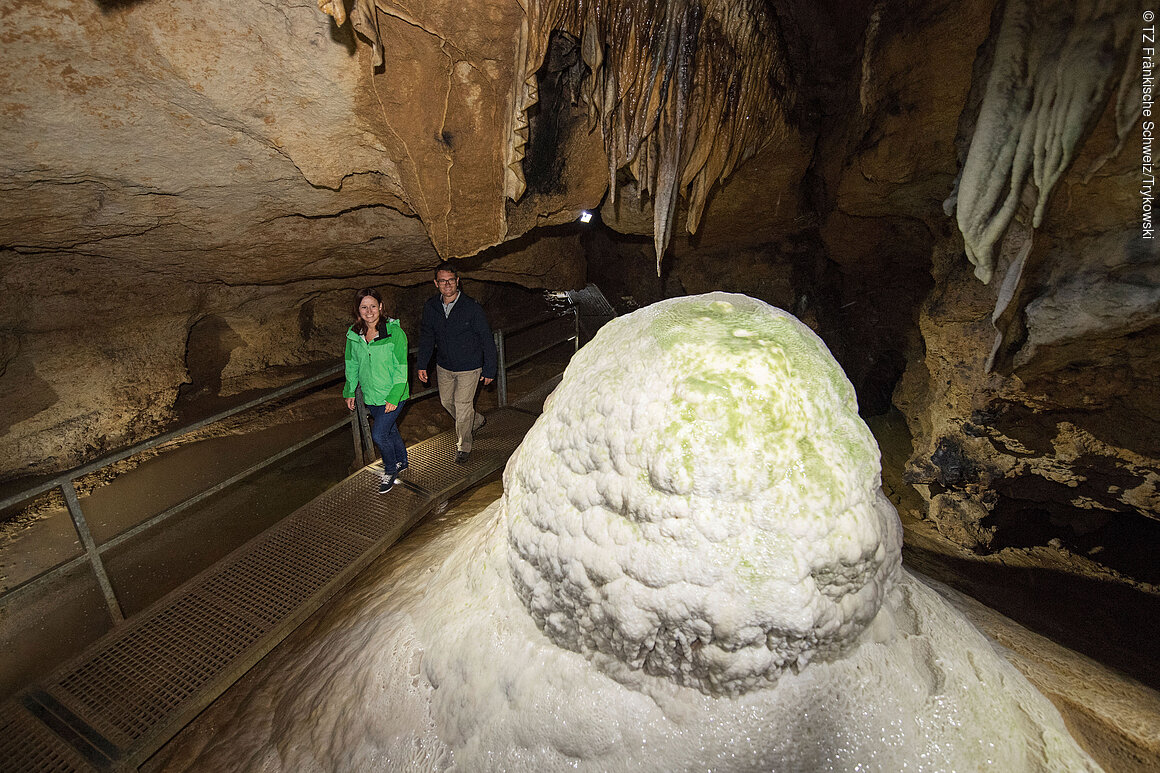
(896, 103, 1160, 551)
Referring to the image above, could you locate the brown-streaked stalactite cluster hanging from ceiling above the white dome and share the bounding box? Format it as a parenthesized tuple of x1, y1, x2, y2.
(506, 0, 790, 272)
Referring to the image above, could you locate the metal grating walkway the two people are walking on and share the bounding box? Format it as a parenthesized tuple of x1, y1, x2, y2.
(0, 387, 558, 773)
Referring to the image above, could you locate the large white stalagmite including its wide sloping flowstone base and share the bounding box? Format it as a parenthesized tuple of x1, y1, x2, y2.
(158, 294, 1099, 773)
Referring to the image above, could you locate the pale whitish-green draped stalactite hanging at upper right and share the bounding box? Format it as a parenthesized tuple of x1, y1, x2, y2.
(952, 0, 1143, 282)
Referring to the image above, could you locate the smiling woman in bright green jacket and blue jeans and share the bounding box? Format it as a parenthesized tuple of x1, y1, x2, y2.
(342, 288, 411, 493)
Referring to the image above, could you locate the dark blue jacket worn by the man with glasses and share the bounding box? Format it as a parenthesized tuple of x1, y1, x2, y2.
(415, 290, 495, 378)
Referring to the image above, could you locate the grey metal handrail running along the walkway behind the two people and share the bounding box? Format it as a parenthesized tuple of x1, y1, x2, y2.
(0, 309, 580, 624)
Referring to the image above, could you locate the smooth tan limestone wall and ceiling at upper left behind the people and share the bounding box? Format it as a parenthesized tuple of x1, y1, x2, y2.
(0, 0, 584, 478)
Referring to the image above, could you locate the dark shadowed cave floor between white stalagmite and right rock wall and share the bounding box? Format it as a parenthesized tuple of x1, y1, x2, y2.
(868, 412, 1160, 689)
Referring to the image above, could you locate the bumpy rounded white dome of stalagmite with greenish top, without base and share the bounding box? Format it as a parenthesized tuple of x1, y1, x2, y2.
(503, 294, 901, 694)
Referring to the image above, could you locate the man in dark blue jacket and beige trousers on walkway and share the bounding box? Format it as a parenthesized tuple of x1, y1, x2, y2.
(415, 260, 495, 464)
